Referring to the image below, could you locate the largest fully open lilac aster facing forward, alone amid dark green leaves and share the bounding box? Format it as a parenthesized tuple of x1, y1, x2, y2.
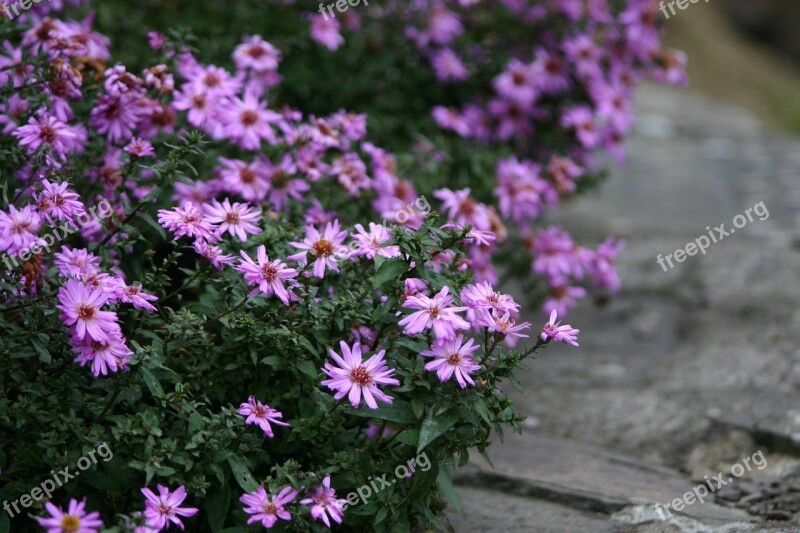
(321, 341, 400, 409)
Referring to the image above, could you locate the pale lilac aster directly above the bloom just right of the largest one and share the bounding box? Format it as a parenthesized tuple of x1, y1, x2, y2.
(398, 286, 469, 339)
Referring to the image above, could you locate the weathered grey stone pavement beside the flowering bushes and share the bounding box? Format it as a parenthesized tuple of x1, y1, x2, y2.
(450, 86, 800, 533)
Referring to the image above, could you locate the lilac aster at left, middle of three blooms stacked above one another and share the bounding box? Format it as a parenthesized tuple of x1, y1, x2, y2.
(56, 279, 119, 342)
